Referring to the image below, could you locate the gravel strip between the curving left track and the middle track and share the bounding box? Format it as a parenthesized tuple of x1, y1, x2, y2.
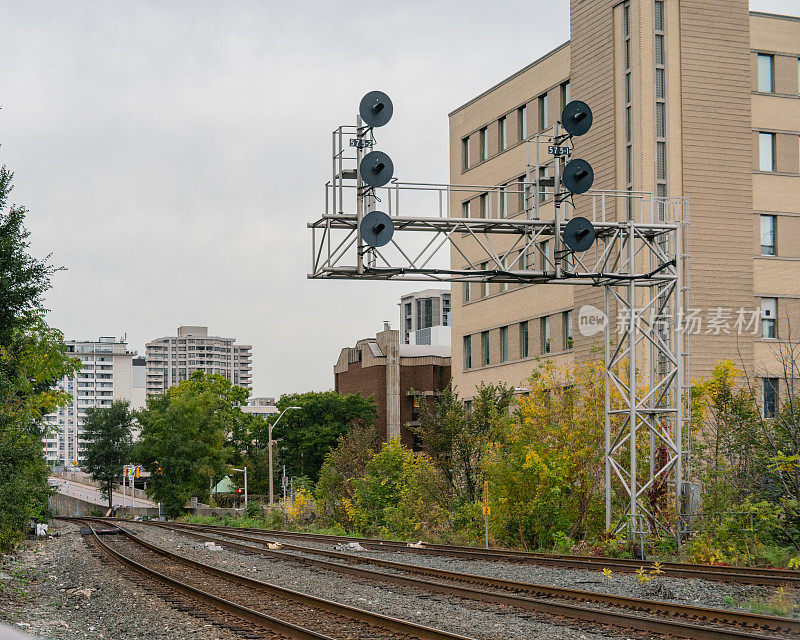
(125, 524, 672, 640)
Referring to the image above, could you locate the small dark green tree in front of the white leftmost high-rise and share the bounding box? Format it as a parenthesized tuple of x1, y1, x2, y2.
(80, 400, 133, 509)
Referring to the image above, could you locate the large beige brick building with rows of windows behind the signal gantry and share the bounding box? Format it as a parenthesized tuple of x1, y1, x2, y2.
(450, 0, 800, 410)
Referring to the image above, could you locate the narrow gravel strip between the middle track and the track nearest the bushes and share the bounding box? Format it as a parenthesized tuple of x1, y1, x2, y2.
(172, 532, 784, 611)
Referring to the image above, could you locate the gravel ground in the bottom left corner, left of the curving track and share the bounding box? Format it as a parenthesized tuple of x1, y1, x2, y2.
(0, 521, 244, 640)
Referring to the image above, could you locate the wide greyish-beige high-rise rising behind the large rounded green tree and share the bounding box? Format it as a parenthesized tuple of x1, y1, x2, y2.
(145, 326, 253, 395)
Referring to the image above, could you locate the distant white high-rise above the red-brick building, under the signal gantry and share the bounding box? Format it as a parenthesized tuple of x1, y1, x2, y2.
(400, 289, 450, 345)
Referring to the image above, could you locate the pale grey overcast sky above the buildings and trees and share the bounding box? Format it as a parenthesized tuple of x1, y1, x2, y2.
(0, 0, 800, 395)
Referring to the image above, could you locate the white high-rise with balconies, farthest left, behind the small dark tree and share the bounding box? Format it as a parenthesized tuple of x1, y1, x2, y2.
(44, 337, 144, 467)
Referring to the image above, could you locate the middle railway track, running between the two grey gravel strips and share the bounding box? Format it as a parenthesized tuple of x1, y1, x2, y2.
(112, 523, 800, 640)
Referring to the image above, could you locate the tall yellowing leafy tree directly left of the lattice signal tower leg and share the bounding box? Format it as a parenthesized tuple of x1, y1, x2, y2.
(484, 361, 605, 548)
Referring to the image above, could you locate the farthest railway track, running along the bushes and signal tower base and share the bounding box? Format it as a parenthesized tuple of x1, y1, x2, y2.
(162, 523, 800, 588)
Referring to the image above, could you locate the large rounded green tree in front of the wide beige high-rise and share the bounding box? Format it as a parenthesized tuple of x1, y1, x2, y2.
(135, 371, 250, 517)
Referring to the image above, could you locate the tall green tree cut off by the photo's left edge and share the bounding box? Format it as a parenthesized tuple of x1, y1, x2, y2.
(0, 166, 79, 551)
